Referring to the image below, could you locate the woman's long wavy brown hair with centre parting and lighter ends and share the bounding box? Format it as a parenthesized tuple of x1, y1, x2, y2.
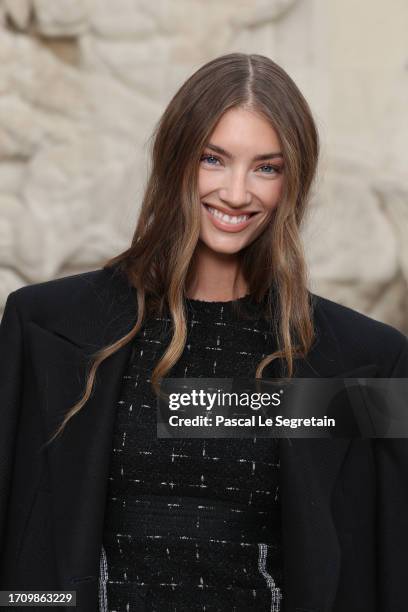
(50, 53, 319, 441)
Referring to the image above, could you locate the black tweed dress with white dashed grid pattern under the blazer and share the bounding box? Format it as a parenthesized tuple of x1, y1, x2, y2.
(100, 295, 284, 612)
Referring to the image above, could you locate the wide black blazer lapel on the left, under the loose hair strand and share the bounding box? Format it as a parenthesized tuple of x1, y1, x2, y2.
(28, 268, 137, 612)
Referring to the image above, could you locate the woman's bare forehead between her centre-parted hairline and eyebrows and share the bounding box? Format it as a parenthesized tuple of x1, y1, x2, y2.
(209, 108, 280, 153)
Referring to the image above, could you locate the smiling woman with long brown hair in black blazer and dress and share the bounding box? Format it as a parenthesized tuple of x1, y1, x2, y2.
(0, 53, 408, 612)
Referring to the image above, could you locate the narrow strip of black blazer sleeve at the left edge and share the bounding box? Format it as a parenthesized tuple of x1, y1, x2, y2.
(0, 292, 23, 566)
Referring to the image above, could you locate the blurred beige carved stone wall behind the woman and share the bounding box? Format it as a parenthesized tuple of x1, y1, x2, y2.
(0, 0, 408, 332)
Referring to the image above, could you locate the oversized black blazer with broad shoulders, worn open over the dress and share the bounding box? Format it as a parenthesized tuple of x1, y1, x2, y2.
(0, 268, 408, 612)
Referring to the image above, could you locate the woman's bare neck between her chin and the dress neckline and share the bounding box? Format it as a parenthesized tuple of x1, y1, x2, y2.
(187, 242, 248, 302)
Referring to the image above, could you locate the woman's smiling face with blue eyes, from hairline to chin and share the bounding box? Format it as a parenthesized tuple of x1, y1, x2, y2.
(198, 108, 283, 255)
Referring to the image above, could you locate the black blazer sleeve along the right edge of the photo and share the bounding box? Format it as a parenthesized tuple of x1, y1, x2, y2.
(374, 339, 408, 612)
